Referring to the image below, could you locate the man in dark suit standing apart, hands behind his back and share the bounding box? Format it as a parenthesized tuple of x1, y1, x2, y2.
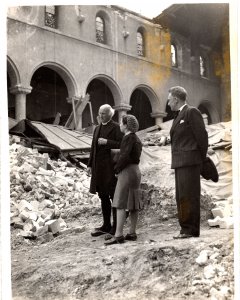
(168, 86, 208, 239)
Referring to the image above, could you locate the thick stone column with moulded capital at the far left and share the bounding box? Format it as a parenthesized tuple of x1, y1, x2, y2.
(9, 85, 32, 121)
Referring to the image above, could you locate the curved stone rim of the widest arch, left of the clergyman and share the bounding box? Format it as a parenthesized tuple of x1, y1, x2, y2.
(29, 61, 79, 98)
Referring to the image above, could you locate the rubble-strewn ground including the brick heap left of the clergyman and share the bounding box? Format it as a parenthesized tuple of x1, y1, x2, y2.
(10, 138, 234, 300)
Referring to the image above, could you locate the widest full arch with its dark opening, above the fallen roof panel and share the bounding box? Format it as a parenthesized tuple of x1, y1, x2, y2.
(26, 61, 79, 125)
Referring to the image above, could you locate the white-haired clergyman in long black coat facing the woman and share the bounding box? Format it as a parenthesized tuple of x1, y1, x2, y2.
(88, 104, 123, 237)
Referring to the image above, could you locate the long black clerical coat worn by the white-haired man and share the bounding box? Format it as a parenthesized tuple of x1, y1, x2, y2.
(87, 120, 123, 194)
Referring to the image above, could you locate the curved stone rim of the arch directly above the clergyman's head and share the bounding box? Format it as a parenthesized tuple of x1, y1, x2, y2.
(85, 74, 123, 106)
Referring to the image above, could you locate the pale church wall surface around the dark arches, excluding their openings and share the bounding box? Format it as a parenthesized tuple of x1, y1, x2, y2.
(7, 5, 227, 126)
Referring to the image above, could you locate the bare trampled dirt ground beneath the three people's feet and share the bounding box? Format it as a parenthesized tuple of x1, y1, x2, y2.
(12, 208, 234, 300)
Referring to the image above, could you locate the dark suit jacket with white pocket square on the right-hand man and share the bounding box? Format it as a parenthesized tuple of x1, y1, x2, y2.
(170, 105, 208, 169)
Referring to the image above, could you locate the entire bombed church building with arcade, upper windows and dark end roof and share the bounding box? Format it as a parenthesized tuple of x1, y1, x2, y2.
(7, 4, 231, 129)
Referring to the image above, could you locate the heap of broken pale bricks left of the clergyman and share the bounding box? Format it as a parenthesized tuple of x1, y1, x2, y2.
(10, 137, 99, 238)
